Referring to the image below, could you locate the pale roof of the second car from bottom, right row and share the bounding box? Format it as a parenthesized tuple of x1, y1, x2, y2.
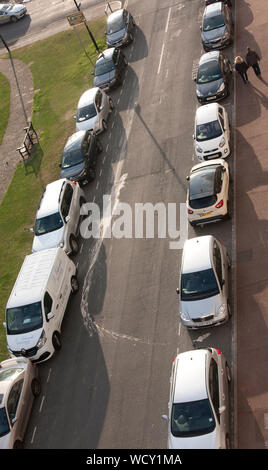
(181, 235, 214, 274)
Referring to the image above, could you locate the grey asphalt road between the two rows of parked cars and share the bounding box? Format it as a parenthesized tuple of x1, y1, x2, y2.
(25, 0, 234, 449)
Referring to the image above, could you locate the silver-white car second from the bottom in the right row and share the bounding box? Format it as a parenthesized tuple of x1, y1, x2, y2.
(177, 235, 231, 329)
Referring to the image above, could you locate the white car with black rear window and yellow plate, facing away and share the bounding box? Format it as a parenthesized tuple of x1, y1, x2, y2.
(186, 158, 229, 226)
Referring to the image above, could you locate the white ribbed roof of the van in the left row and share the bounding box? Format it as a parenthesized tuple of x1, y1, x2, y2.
(6, 247, 61, 308)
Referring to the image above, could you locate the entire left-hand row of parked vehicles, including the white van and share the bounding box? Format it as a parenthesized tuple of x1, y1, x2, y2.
(0, 7, 135, 448)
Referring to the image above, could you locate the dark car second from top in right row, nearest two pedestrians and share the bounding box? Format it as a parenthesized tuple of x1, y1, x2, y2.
(195, 51, 232, 104)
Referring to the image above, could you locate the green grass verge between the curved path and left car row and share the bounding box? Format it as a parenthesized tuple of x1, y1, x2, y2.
(0, 18, 106, 360)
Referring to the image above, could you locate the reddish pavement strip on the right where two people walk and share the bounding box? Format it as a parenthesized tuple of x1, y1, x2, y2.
(235, 0, 268, 449)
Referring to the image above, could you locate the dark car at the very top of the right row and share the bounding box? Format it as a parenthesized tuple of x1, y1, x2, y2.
(200, 2, 233, 51)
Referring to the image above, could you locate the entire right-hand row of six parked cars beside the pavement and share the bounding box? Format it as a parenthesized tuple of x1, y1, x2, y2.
(163, 0, 233, 449)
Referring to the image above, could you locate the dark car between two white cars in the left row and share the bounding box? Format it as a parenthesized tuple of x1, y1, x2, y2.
(59, 131, 102, 186)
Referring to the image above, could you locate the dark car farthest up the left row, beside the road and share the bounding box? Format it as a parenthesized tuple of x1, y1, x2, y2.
(106, 8, 136, 47)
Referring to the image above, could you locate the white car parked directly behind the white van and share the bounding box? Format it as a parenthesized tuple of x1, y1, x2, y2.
(31, 178, 86, 254)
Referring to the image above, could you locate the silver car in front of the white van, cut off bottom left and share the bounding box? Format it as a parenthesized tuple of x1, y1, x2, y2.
(0, 358, 41, 449)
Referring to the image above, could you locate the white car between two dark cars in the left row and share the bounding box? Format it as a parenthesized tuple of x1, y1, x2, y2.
(75, 87, 114, 134)
